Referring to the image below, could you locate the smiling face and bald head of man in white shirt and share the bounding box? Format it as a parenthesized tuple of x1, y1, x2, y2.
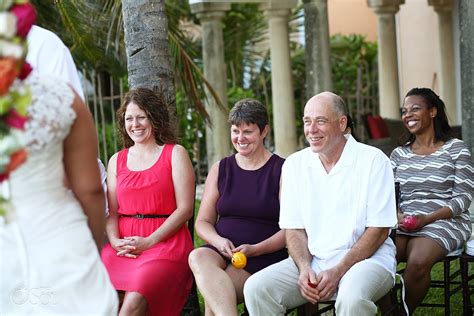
(303, 94, 347, 155)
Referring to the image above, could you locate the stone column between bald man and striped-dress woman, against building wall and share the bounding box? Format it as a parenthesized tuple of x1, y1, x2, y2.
(367, 0, 405, 119)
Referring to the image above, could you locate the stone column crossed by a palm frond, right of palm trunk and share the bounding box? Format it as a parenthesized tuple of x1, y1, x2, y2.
(191, 2, 230, 169)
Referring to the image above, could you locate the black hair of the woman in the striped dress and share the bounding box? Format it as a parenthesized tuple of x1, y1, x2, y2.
(401, 88, 453, 146)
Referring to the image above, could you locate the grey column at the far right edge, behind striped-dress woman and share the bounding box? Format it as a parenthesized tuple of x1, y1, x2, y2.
(459, 0, 474, 160)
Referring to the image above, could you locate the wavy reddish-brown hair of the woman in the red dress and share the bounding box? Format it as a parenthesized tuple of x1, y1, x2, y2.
(116, 88, 178, 148)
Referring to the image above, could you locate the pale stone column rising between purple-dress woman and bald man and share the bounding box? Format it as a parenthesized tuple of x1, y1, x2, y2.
(262, 0, 297, 157)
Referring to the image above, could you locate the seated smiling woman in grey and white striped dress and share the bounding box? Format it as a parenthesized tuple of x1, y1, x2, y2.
(390, 88, 474, 314)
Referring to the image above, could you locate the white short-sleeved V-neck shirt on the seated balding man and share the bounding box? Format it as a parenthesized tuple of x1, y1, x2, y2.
(279, 135, 397, 275)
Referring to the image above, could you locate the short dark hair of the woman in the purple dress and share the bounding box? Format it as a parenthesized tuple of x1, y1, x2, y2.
(229, 99, 268, 133)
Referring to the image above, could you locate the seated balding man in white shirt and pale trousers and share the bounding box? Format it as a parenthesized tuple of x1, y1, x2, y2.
(244, 92, 397, 316)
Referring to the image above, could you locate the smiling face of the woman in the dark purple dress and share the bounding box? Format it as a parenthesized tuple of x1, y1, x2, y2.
(230, 123, 268, 156)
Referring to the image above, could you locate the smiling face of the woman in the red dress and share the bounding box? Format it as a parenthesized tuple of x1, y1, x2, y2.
(124, 102, 155, 144)
